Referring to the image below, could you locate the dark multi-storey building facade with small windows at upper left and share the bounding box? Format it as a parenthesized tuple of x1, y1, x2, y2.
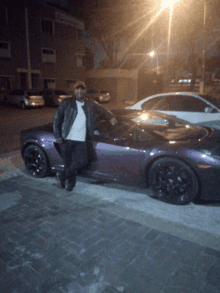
(0, 0, 85, 92)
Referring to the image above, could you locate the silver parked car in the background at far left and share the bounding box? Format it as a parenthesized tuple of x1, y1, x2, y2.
(5, 89, 44, 109)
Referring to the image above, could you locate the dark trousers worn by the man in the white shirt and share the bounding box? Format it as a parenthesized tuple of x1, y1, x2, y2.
(60, 139, 88, 179)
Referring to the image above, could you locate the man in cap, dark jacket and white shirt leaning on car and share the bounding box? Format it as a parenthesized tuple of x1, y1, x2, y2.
(53, 81, 117, 191)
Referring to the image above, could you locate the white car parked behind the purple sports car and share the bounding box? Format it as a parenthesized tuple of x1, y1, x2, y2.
(127, 92, 220, 129)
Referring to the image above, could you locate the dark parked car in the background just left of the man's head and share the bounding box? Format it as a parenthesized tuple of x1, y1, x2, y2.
(41, 89, 72, 107)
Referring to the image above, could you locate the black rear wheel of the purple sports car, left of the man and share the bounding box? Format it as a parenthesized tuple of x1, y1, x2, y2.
(23, 145, 50, 178)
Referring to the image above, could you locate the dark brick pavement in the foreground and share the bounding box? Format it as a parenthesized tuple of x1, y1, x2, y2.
(0, 176, 220, 293)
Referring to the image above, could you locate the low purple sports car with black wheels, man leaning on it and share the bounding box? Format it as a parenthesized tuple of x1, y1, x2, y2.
(20, 110, 220, 204)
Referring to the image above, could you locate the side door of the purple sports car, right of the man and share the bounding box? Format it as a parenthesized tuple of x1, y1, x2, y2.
(86, 123, 145, 182)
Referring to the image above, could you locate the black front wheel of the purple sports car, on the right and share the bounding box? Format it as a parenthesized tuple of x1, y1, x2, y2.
(148, 158, 199, 205)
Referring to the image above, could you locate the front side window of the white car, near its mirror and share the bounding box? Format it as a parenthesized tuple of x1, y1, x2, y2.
(167, 95, 208, 113)
